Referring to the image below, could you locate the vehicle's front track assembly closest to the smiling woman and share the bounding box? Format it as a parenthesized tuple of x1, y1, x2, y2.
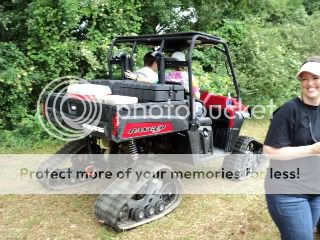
(222, 136, 264, 180)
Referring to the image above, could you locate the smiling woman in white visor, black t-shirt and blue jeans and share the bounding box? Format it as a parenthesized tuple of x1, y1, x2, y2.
(263, 56, 320, 240)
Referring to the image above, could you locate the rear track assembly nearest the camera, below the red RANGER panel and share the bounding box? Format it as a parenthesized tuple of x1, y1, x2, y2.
(95, 161, 182, 231)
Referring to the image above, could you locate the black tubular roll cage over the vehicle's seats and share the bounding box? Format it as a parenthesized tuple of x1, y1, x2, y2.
(108, 32, 240, 122)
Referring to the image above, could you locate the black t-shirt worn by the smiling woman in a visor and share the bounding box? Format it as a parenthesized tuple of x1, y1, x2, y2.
(264, 97, 320, 194)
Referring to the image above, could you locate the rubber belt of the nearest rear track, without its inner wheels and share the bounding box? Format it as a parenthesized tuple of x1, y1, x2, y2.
(95, 161, 182, 231)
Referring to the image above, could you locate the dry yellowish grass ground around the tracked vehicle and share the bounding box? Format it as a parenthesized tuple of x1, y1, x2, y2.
(0, 120, 279, 240)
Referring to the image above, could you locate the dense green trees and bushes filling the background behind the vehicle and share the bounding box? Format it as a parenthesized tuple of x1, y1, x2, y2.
(0, 0, 320, 144)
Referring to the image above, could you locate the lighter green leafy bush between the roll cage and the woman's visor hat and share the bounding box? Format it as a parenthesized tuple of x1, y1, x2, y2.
(228, 11, 320, 104)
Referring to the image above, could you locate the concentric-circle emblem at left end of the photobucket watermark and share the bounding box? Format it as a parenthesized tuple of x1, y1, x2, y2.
(36, 76, 102, 141)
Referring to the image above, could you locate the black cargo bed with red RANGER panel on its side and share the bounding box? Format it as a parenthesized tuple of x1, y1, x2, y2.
(46, 93, 189, 142)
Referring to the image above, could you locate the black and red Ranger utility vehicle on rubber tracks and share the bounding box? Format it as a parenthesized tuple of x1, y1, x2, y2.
(40, 32, 262, 231)
